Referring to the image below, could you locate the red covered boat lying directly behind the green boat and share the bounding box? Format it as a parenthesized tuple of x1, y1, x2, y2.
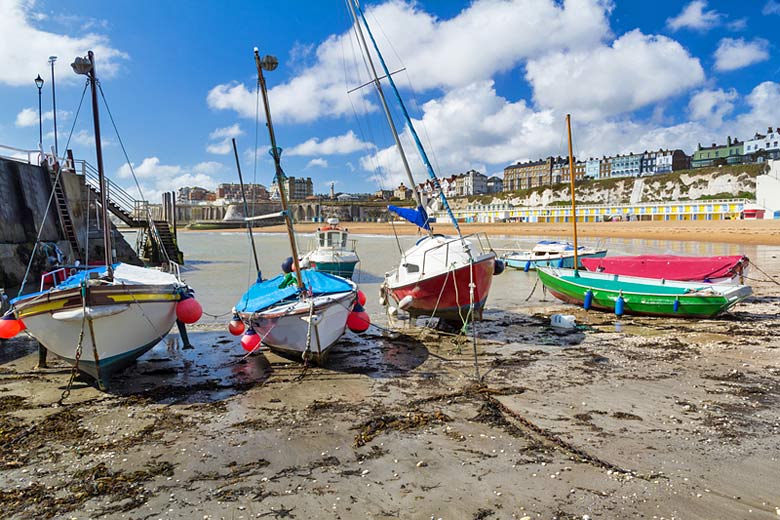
(580, 255, 750, 283)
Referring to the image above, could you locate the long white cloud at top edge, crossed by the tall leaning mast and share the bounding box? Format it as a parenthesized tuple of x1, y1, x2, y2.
(207, 0, 611, 122)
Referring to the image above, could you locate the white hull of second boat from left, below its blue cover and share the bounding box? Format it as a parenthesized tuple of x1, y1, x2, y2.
(241, 290, 357, 363)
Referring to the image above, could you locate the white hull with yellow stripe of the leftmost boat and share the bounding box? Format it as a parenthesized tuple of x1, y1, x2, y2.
(14, 285, 180, 382)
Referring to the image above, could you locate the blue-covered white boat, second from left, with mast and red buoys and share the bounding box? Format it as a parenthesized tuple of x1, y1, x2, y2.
(230, 48, 368, 364)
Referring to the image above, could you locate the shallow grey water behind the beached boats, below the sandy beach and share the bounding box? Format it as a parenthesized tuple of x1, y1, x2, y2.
(154, 231, 780, 324)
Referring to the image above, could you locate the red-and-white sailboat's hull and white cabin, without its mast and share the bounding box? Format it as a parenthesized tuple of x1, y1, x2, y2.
(382, 235, 497, 323)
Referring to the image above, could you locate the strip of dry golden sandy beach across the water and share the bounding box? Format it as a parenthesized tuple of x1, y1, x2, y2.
(184, 220, 780, 245)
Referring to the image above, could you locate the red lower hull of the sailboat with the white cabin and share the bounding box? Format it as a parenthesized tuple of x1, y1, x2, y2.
(387, 253, 496, 321)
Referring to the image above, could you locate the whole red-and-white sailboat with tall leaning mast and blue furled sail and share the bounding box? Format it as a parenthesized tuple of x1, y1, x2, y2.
(347, 0, 503, 324)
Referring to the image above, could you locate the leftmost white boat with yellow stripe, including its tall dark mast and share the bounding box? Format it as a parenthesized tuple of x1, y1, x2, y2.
(11, 51, 192, 388)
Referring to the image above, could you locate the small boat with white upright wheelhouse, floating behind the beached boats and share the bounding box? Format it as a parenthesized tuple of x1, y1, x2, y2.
(301, 218, 360, 278)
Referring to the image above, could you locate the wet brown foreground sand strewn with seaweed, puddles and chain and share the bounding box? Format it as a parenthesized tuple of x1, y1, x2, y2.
(0, 246, 780, 519)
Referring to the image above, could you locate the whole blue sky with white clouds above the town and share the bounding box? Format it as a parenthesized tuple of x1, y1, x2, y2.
(0, 0, 780, 202)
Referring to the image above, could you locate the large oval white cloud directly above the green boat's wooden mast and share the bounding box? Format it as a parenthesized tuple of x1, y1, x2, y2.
(526, 30, 704, 120)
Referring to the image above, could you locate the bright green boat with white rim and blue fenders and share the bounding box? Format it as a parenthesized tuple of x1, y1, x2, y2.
(536, 267, 753, 318)
